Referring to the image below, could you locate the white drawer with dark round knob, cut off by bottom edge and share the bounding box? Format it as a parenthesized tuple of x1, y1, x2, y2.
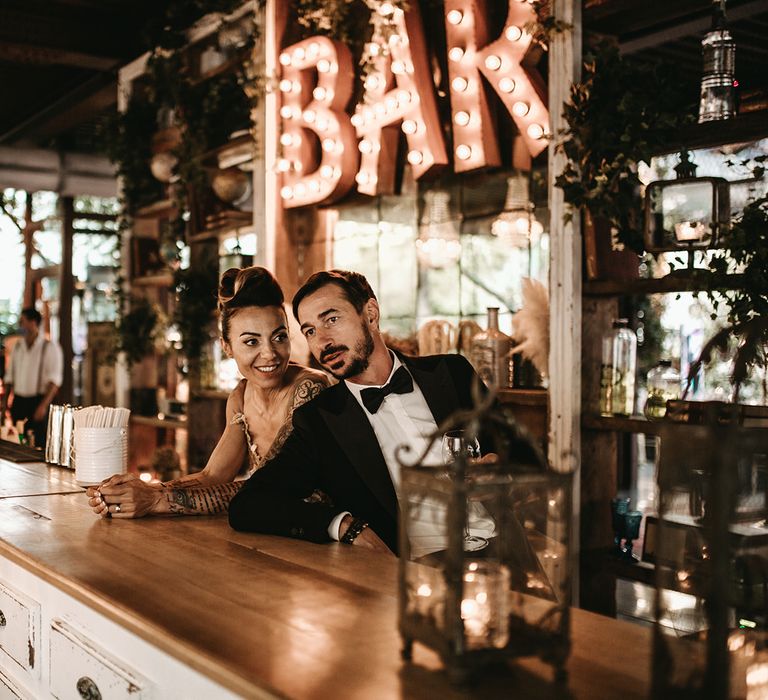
(50, 620, 149, 700)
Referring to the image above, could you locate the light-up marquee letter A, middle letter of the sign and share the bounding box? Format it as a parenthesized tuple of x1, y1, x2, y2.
(352, 0, 448, 195)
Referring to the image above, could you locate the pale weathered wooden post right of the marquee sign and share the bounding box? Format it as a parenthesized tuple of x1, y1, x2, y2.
(548, 0, 581, 602)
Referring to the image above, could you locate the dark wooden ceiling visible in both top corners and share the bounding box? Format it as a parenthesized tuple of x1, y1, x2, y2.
(0, 0, 768, 150)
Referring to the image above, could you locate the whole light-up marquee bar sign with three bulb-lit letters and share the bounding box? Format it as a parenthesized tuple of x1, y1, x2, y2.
(277, 0, 549, 208)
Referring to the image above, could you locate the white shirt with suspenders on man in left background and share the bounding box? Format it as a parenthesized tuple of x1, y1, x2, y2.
(5, 333, 64, 397)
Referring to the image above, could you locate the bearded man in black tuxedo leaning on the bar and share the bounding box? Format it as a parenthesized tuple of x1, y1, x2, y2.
(229, 270, 528, 553)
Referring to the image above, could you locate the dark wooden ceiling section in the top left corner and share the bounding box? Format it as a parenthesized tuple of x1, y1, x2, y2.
(0, 0, 165, 150)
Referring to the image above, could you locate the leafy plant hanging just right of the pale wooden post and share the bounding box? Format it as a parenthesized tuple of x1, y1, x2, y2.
(555, 41, 695, 253)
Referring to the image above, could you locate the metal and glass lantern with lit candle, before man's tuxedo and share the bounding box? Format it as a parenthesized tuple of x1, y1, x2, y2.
(399, 403, 572, 682)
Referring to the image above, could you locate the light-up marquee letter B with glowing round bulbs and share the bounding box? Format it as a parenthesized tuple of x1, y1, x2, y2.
(277, 36, 357, 208)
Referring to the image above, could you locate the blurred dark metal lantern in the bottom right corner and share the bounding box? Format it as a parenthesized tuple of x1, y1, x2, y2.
(644, 402, 768, 700)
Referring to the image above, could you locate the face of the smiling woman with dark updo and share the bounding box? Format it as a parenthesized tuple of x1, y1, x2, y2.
(222, 306, 291, 389)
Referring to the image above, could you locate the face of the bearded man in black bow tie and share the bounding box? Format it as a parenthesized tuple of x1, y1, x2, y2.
(298, 284, 374, 379)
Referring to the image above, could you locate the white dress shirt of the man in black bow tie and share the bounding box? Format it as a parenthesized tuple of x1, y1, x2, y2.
(328, 351, 494, 558)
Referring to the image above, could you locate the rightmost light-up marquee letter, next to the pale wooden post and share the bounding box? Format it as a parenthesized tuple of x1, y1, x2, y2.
(445, 0, 549, 172)
